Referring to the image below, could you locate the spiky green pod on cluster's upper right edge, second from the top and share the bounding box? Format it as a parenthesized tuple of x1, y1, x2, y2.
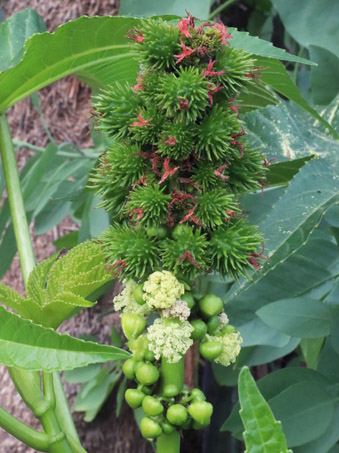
(214, 46, 257, 99)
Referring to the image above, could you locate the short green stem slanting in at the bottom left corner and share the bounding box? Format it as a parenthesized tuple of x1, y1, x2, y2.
(0, 408, 50, 451)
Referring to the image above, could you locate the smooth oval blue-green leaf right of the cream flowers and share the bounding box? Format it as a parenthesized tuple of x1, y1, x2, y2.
(256, 297, 331, 338)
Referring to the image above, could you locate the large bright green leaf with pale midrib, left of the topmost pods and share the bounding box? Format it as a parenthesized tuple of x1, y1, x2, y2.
(0, 16, 140, 112)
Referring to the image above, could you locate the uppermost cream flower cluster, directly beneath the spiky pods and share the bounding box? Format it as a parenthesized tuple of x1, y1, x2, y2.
(143, 271, 185, 309)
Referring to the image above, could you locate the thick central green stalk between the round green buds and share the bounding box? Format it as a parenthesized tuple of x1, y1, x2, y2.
(157, 358, 184, 453)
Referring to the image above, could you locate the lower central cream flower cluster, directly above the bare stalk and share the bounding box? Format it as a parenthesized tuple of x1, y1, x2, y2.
(147, 318, 194, 363)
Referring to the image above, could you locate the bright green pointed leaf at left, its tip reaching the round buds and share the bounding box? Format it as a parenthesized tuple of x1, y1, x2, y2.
(0, 306, 130, 372)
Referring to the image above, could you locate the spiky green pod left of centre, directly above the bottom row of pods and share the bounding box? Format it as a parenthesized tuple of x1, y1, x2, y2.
(127, 184, 171, 226)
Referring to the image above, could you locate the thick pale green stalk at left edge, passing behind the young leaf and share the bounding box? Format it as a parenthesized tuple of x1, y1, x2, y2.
(0, 115, 79, 453)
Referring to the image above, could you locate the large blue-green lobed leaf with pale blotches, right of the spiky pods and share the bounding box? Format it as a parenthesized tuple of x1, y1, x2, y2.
(229, 99, 339, 300)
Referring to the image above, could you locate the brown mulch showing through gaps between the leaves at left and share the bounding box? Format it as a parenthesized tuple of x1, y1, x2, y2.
(0, 0, 152, 453)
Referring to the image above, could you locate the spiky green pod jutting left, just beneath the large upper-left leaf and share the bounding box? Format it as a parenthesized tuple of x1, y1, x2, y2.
(93, 83, 141, 138)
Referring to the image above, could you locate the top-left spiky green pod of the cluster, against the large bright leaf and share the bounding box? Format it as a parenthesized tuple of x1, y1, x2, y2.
(138, 20, 180, 70)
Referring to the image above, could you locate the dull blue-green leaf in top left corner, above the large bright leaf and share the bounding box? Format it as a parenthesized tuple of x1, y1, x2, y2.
(0, 9, 46, 72)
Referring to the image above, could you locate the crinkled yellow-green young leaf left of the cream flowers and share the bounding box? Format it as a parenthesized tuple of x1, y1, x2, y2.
(0, 241, 112, 328)
